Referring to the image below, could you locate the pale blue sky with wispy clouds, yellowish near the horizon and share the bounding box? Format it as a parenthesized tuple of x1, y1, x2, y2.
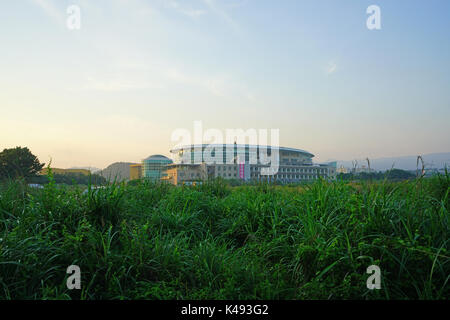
(0, 0, 450, 168)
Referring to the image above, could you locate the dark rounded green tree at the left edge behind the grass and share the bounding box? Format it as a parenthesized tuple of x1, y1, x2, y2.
(0, 147, 45, 179)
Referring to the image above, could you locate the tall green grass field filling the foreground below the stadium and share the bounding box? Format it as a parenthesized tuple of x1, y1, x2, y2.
(0, 175, 450, 299)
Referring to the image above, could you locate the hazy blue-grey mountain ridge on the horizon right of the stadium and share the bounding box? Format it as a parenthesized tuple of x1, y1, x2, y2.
(337, 152, 450, 171)
